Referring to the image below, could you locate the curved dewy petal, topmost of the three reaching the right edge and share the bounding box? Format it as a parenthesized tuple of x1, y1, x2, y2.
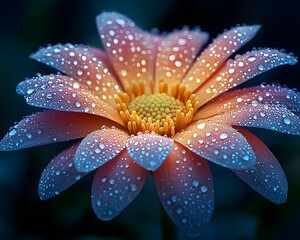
(195, 49, 297, 105)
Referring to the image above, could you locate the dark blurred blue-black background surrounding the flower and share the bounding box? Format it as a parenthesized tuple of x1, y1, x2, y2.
(0, 0, 300, 240)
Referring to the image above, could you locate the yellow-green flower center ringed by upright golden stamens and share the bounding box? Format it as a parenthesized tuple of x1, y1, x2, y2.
(115, 83, 199, 137)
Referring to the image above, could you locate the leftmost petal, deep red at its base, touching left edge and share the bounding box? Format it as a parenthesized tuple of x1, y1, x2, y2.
(0, 110, 112, 151)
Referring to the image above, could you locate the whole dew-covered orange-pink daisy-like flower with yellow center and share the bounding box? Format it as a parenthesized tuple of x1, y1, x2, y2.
(0, 13, 300, 237)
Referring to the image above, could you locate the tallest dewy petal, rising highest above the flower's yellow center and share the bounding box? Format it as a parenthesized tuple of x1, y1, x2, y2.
(96, 13, 159, 91)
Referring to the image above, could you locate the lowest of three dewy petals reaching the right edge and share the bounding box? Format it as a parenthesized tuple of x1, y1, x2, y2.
(209, 102, 300, 135)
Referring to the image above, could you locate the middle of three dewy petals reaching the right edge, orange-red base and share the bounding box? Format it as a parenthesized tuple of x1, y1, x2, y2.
(194, 84, 300, 119)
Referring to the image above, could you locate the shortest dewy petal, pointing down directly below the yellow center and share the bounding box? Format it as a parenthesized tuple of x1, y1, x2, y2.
(126, 133, 174, 171)
